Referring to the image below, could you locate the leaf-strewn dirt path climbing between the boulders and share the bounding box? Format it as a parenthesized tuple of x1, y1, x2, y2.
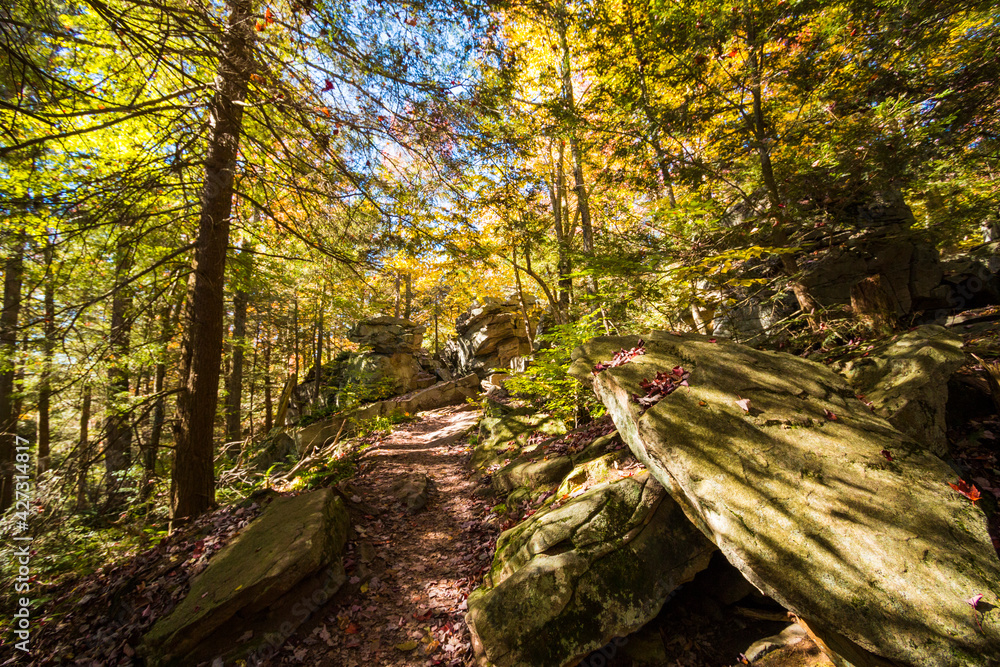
(258, 406, 496, 667)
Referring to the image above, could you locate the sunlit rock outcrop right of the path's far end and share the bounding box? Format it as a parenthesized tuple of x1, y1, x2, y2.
(441, 294, 541, 378)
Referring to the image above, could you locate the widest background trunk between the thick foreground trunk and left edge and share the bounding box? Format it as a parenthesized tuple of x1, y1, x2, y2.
(104, 228, 133, 495)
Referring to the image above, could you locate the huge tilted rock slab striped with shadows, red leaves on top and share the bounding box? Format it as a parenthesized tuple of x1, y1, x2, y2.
(570, 332, 1000, 667)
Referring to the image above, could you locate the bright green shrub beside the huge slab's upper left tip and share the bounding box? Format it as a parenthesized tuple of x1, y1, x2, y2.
(505, 310, 603, 423)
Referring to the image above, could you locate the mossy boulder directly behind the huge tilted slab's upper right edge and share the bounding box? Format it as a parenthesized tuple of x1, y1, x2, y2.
(838, 324, 965, 455)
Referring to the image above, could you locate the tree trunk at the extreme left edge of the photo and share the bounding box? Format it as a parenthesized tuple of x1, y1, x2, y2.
(0, 229, 25, 512)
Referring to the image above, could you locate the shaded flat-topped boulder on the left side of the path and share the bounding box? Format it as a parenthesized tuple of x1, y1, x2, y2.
(140, 489, 349, 665)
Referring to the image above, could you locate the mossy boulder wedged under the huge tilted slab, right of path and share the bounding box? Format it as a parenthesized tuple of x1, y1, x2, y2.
(466, 472, 715, 667)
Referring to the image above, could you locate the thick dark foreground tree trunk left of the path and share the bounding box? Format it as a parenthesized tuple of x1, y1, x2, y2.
(171, 0, 254, 528)
